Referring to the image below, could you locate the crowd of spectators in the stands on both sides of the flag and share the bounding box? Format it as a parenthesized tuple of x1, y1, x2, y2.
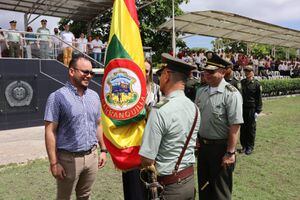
(0, 19, 300, 74)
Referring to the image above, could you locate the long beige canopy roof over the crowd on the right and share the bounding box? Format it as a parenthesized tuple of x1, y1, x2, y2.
(159, 10, 300, 48)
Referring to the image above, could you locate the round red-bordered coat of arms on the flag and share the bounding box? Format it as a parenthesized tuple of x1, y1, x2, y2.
(101, 59, 146, 120)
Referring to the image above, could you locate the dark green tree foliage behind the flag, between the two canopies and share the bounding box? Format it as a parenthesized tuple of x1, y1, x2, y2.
(59, 0, 189, 62)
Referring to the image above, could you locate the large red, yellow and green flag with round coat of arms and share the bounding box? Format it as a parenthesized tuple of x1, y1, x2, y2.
(101, 0, 146, 170)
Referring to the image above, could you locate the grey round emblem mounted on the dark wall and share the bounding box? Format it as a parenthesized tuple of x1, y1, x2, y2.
(5, 81, 33, 107)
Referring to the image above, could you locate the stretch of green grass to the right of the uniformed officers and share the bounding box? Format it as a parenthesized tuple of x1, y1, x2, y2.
(233, 96, 300, 200)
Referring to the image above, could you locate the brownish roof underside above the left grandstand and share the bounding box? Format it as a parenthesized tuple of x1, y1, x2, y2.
(0, 0, 113, 20)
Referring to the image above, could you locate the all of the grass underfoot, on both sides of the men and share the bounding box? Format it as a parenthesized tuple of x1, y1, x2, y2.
(0, 96, 300, 200)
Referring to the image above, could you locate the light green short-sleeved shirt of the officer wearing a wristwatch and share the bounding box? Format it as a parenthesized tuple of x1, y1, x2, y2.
(195, 79, 243, 139)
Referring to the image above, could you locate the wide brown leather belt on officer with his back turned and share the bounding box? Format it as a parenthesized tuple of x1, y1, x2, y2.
(157, 166, 194, 185)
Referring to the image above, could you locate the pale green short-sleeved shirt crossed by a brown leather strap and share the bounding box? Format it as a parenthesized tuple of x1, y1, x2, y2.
(139, 90, 200, 175)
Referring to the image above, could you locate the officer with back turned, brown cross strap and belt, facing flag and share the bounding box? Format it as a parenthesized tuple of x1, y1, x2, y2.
(139, 53, 200, 200)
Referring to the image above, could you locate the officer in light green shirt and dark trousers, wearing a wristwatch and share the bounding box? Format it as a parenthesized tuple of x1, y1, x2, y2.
(195, 51, 243, 200)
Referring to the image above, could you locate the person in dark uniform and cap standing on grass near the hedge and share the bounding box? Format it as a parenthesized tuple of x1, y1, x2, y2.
(240, 65, 262, 155)
